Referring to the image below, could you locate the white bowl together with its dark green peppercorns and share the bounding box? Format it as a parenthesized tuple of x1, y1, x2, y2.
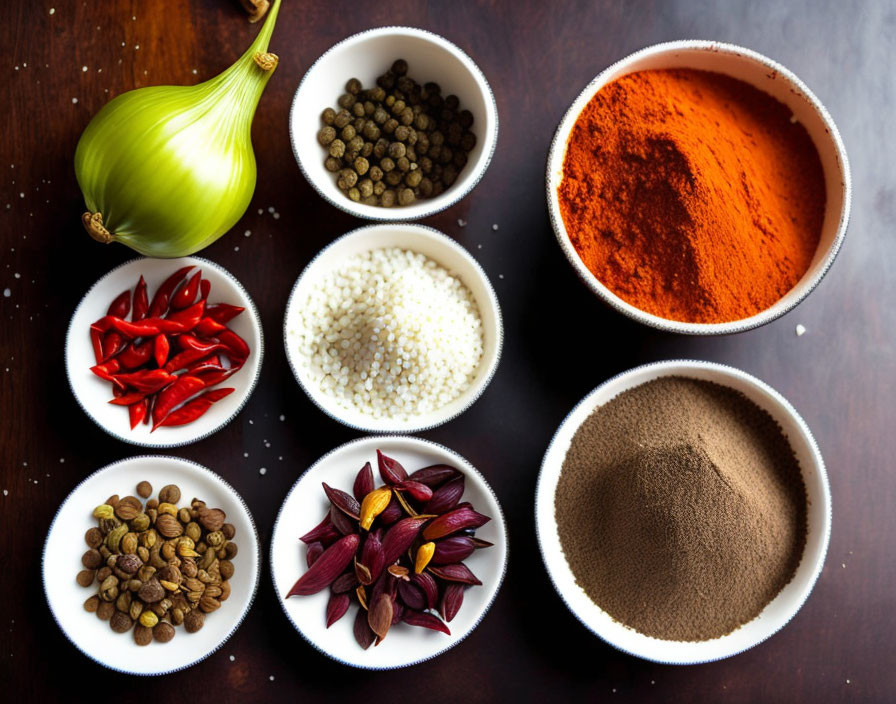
(289, 27, 498, 221)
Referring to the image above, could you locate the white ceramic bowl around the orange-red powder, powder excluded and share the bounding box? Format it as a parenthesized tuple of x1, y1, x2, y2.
(546, 40, 852, 335)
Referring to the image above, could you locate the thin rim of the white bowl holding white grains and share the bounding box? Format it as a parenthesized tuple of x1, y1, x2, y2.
(283, 222, 504, 435)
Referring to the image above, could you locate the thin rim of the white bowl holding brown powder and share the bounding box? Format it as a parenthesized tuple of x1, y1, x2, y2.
(534, 359, 833, 665)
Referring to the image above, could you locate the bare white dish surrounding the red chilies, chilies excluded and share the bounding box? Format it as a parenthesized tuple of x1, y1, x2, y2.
(65, 257, 264, 448)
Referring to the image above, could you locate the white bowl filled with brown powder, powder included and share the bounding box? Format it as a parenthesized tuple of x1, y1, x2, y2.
(535, 361, 831, 664)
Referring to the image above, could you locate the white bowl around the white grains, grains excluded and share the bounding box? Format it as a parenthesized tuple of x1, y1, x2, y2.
(283, 224, 504, 433)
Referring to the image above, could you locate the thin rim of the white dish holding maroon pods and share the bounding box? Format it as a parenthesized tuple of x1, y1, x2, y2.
(268, 435, 510, 672)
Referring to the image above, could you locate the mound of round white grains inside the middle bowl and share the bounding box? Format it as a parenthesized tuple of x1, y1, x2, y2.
(297, 248, 483, 420)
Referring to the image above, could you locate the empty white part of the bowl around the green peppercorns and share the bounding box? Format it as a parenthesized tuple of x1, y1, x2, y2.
(289, 27, 498, 222)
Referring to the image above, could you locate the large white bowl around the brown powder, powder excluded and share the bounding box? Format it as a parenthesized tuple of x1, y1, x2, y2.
(535, 360, 831, 665)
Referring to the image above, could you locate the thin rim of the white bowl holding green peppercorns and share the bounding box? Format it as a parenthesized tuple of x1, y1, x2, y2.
(287, 25, 499, 222)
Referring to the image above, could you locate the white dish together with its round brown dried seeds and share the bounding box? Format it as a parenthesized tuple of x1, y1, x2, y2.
(42, 456, 261, 675)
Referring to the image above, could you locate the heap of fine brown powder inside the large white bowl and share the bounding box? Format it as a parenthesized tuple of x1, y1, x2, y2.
(555, 377, 807, 641)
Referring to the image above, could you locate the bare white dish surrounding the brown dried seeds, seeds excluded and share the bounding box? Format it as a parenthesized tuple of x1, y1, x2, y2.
(41, 456, 261, 675)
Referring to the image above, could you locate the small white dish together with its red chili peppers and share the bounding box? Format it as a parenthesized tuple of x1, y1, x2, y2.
(65, 257, 263, 447)
